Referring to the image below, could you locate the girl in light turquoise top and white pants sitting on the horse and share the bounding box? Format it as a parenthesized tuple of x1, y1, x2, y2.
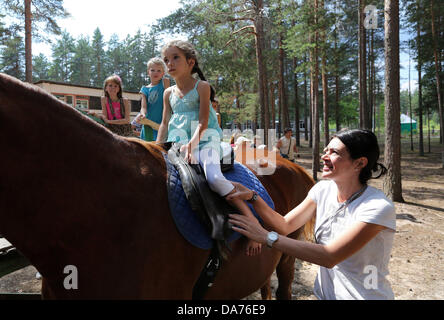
(156, 40, 261, 256)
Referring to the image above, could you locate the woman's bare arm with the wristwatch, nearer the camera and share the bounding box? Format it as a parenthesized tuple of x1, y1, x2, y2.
(230, 214, 385, 268)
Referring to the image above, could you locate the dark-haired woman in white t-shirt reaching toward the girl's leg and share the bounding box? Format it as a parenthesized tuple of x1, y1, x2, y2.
(229, 129, 396, 299)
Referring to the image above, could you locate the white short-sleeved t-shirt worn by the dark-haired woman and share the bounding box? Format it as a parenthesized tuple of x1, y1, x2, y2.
(308, 180, 396, 300)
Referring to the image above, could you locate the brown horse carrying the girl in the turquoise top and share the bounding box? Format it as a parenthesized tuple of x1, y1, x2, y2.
(0, 74, 313, 299)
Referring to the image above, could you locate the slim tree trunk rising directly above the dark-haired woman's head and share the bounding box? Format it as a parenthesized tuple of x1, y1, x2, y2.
(358, 0, 371, 129)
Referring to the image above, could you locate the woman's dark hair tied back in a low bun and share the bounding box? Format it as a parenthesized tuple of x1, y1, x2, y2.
(332, 129, 387, 184)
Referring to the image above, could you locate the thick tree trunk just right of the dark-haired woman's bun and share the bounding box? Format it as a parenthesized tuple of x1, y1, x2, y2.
(383, 0, 404, 202)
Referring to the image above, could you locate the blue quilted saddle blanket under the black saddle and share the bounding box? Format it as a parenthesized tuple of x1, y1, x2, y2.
(165, 157, 274, 250)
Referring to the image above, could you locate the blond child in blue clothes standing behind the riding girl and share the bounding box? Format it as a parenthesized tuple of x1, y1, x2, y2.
(136, 57, 170, 141)
